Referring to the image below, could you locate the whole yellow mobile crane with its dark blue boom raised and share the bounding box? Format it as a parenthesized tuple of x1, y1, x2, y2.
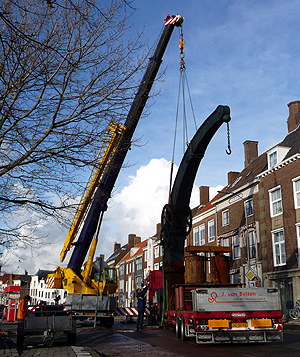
(47, 15, 183, 325)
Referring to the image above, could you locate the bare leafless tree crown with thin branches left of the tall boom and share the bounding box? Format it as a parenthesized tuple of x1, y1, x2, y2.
(0, 0, 145, 246)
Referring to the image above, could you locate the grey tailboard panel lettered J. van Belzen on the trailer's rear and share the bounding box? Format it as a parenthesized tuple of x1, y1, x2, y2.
(193, 288, 280, 312)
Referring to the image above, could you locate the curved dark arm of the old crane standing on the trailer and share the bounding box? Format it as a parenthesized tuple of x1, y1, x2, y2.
(161, 105, 230, 308)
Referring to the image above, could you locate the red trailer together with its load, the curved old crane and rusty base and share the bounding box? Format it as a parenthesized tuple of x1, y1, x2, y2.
(148, 106, 283, 343)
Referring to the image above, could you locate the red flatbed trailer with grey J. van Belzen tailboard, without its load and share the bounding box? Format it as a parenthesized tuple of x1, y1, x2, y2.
(164, 284, 283, 344)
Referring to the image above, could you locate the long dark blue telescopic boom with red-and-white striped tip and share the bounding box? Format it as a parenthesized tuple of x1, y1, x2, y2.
(68, 15, 183, 275)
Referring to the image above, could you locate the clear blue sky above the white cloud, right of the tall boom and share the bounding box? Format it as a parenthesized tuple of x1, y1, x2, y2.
(118, 0, 300, 186)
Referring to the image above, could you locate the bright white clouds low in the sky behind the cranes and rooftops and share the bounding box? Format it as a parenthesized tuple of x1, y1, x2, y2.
(2, 158, 222, 274)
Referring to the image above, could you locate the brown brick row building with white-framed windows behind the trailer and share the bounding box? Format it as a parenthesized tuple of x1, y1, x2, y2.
(188, 101, 300, 313)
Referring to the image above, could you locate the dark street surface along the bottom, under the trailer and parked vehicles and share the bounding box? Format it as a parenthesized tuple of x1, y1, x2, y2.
(0, 318, 300, 357)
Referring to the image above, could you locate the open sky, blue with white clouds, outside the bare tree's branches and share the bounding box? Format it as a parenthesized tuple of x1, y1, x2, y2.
(2, 0, 300, 274)
